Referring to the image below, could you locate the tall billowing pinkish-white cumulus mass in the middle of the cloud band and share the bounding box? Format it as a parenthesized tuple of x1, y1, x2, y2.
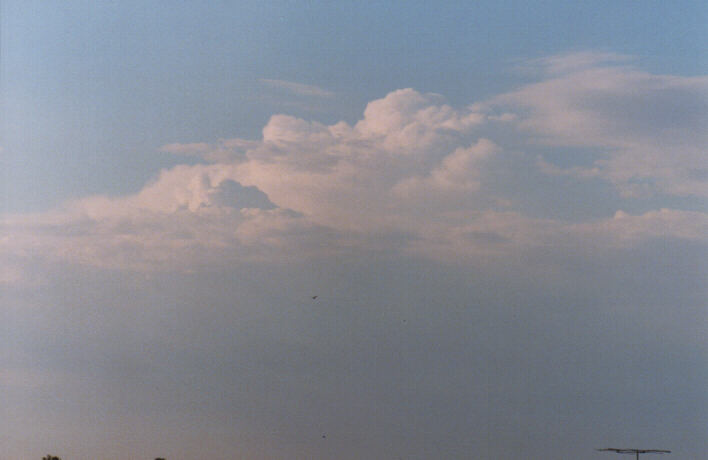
(232, 89, 492, 231)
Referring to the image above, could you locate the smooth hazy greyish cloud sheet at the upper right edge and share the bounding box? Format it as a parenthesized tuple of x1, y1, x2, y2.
(492, 54, 708, 197)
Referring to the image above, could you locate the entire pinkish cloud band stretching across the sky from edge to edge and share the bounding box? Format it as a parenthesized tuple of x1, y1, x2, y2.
(0, 53, 708, 276)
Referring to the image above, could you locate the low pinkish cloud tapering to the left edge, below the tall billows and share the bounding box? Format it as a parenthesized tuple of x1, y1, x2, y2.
(0, 164, 317, 272)
